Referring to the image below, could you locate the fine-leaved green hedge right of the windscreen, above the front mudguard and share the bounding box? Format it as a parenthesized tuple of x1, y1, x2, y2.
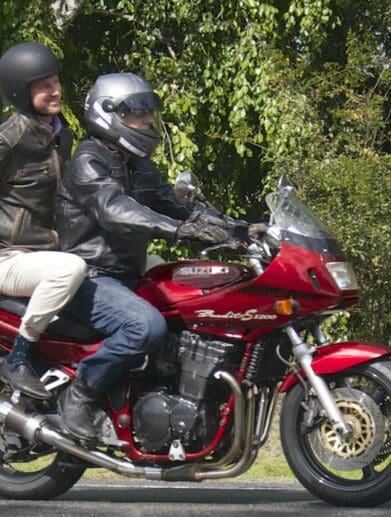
(303, 156, 391, 342)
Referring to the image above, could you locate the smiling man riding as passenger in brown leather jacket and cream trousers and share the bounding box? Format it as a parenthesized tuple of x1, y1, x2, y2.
(0, 42, 86, 399)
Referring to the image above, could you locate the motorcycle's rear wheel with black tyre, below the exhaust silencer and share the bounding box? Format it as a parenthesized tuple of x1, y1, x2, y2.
(0, 382, 85, 500)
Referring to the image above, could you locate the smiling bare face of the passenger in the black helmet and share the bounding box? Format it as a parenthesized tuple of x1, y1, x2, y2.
(30, 74, 61, 117)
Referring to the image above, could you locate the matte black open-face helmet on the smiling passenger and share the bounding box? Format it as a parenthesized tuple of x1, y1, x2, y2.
(0, 42, 61, 111)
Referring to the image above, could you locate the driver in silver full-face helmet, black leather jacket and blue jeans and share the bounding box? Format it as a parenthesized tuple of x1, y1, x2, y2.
(57, 73, 228, 440)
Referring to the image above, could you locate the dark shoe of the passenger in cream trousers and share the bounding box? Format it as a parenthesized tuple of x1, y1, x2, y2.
(0, 359, 51, 400)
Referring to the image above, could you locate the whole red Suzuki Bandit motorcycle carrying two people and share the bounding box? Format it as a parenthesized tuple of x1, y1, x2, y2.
(0, 173, 391, 507)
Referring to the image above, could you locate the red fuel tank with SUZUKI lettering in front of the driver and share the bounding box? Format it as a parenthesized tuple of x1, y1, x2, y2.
(135, 260, 255, 309)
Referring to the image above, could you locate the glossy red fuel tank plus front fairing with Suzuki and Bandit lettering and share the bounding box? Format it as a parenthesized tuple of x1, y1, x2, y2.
(135, 242, 358, 342)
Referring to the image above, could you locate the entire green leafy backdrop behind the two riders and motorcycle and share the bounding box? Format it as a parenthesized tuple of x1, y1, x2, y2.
(0, 0, 391, 341)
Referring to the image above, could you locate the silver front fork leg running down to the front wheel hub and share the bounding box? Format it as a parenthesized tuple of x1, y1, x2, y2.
(285, 325, 350, 436)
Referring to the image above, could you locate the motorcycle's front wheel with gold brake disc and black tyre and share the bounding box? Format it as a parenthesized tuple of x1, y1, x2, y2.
(280, 361, 391, 507)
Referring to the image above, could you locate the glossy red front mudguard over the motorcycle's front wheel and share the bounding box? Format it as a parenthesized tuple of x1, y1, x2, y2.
(278, 341, 391, 393)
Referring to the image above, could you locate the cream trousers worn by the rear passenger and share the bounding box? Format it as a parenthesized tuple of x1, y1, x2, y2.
(0, 250, 87, 333)
